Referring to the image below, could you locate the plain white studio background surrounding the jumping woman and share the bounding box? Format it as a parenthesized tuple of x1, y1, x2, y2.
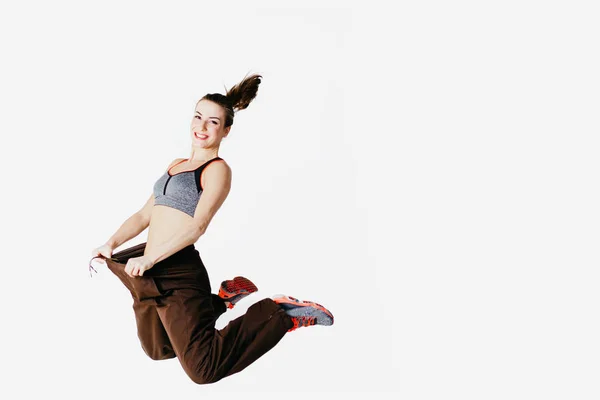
(0, 1, 600, 399)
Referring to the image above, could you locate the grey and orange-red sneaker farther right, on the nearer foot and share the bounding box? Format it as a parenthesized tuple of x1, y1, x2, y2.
(271, 294, 333, 332)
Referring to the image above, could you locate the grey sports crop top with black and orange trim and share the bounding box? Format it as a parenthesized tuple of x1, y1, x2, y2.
(154, 157, 222, 217)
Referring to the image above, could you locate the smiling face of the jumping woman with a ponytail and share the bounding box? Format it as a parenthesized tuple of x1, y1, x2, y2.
(191, 100, 231, 148)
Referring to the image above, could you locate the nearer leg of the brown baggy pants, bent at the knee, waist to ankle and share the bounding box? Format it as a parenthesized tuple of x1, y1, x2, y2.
(153, 249, 293, 384)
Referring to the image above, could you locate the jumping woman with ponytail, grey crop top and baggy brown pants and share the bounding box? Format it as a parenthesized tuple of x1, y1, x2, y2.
(90, 75, 333, 384)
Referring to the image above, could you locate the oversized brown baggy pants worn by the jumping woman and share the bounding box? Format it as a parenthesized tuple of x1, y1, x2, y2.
(106, 243, 293, 384)
